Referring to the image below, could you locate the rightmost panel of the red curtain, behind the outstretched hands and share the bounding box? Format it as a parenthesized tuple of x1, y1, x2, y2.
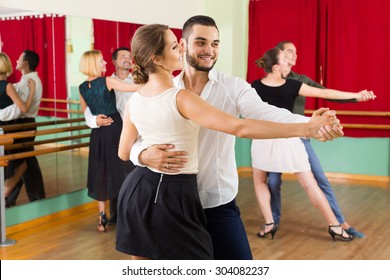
(318, 0, 390, 137)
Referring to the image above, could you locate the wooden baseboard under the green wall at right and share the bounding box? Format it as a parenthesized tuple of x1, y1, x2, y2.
(237, 166, 390, 188)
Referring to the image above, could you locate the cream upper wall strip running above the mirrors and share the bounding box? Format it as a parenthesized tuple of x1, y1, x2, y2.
(0, 0, 205, 28)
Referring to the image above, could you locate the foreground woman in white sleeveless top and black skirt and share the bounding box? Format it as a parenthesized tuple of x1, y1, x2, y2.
(116, 24, 337, 259)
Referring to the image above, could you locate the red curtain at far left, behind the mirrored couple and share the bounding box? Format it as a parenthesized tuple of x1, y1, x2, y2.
(0, 15, 67, 117)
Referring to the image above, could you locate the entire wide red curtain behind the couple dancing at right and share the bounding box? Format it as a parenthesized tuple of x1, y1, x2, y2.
(247, 0, 390, 137)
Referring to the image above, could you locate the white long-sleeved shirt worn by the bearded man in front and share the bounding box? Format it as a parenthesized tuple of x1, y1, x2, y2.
(130, 69, 310, 208)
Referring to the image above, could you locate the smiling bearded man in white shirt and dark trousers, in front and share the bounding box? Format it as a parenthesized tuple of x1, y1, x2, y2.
(131, 16, 343, 259)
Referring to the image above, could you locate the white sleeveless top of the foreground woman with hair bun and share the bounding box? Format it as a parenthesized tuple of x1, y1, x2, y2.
(129, 87, 199, 174)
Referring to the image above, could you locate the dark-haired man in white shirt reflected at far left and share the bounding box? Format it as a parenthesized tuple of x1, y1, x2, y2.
(0, 50, 45, 206)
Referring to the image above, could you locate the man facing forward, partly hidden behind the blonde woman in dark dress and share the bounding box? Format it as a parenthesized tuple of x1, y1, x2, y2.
(84, 47, 134, 225)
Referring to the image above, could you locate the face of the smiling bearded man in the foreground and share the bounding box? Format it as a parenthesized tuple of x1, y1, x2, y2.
(186, 25, 219, 72)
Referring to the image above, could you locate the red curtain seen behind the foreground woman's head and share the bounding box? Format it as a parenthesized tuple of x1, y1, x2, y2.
(93, 19, 181, 75)
